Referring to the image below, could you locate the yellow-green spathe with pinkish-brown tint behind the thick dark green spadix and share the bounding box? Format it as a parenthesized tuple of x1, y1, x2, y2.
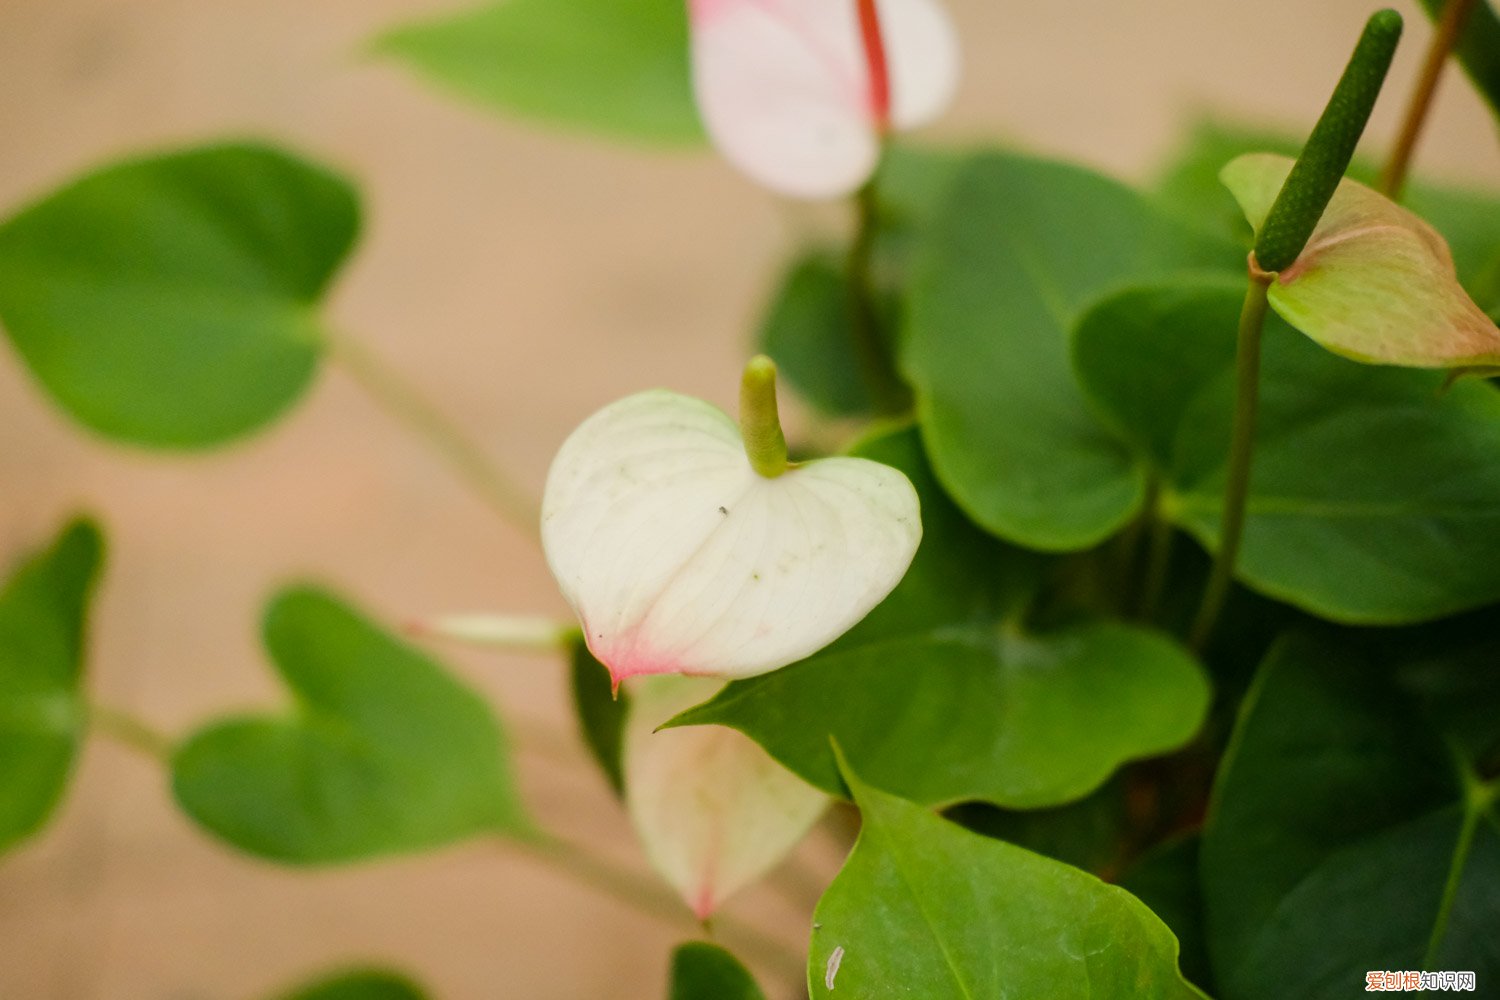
(1220, 153, 1500, 369)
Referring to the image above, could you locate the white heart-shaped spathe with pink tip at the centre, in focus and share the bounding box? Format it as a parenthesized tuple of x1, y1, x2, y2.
(542, 390, 921, 684)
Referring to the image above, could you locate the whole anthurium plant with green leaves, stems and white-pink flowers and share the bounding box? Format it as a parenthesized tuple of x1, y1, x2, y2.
(0, 0, 1500, 1000)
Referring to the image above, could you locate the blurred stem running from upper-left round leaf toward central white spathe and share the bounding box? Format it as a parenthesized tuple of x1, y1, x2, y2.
(330, 337, 542, 541)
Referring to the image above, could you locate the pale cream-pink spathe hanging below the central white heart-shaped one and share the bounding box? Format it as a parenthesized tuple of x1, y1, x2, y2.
(621, 678, 828, 919)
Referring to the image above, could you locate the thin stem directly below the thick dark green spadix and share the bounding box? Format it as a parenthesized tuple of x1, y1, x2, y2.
(1190, 271, 1274, 652)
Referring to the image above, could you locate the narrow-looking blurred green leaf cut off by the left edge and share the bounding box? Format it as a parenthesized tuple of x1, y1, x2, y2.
(0, 520, 104, 853)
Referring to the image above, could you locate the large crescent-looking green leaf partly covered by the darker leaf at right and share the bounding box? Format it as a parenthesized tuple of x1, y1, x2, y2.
(903, 153, 1244, 550)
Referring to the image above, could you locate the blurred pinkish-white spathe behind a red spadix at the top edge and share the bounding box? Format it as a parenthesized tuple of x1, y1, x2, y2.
(689, 0, 959, 198)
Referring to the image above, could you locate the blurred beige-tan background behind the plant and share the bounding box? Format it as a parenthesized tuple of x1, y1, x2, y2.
(0, 0, 1500, 1000)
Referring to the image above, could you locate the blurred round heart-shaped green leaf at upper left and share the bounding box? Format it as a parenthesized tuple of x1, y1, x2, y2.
(0, 145, 359, 448)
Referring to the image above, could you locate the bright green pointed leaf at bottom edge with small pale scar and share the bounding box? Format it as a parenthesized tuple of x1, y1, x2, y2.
(807, 758, 1203, 1000)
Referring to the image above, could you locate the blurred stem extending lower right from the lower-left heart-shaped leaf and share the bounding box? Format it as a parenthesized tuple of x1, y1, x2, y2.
(503, 838, 804, 978)
